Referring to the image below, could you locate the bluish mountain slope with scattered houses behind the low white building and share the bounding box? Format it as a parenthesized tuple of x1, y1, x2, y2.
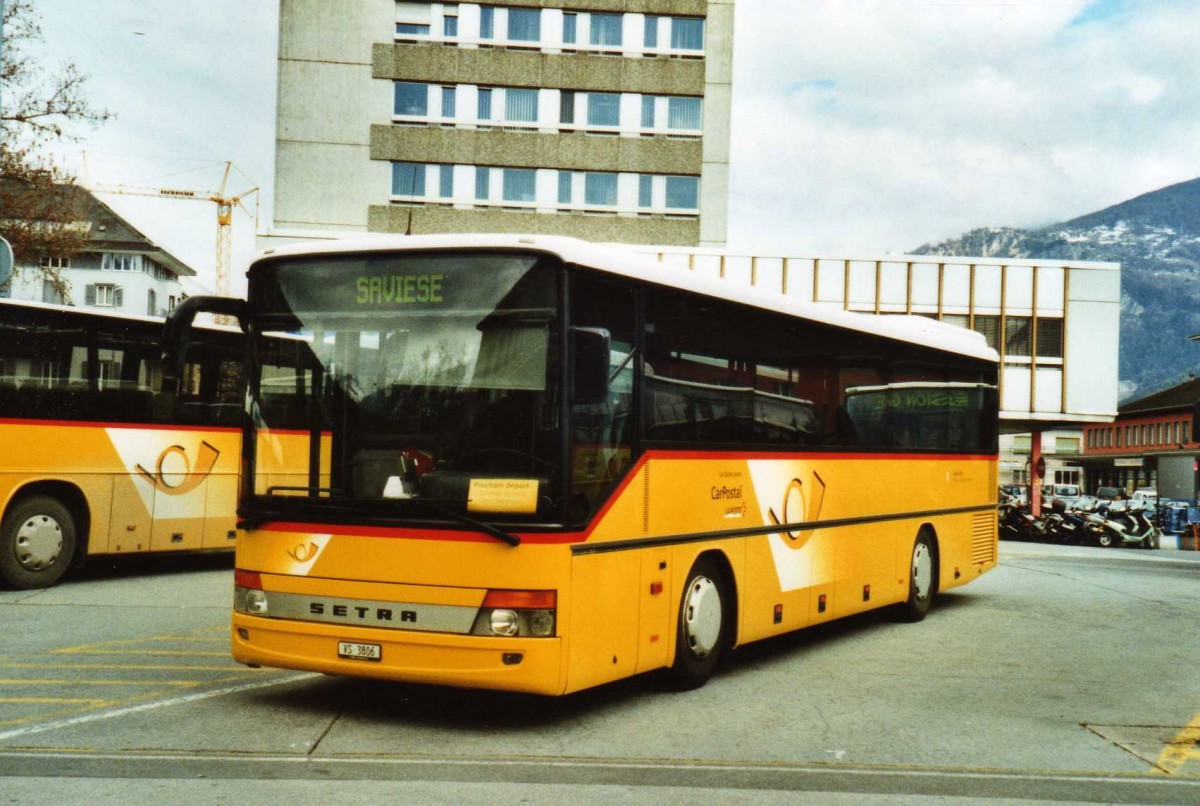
(916, 179, 1200, 397)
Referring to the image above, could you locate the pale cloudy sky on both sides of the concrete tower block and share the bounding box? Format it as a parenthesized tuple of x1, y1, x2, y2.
(25, 0, 1200, 293)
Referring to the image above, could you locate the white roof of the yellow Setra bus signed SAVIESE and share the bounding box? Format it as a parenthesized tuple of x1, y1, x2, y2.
(256, 234, 1000, 362)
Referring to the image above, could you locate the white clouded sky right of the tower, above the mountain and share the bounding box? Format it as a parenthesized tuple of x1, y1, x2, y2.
(730, 0, 1200, 253)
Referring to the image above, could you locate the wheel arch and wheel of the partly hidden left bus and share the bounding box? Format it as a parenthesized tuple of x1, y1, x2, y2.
(0, 481, 90, 589)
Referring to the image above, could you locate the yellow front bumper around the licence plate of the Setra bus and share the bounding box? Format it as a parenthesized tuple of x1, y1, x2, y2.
(232, 613, 563, 694)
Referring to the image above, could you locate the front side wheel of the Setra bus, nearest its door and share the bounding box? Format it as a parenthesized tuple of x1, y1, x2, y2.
(670, 557, 733, 691)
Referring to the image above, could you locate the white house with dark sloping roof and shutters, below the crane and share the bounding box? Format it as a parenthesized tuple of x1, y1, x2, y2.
(0, 186, 196, 317)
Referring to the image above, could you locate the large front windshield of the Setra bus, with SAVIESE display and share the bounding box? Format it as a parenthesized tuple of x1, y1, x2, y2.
(251, 252, 562, 521)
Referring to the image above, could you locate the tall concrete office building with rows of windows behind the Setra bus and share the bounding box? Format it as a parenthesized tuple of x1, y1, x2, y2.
(274, 0, 733, 246)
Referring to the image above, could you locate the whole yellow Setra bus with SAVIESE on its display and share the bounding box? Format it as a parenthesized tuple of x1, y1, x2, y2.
(180, 235, 997, 694)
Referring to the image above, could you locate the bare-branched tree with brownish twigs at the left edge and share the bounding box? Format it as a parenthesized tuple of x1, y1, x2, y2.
(0, 0, 113, 293)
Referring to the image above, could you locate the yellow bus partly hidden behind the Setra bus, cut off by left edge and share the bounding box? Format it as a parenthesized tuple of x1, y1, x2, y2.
(0, 300, 245, 589)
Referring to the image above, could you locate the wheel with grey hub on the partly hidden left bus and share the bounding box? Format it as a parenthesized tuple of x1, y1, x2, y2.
(0, 495, 76, 590)
